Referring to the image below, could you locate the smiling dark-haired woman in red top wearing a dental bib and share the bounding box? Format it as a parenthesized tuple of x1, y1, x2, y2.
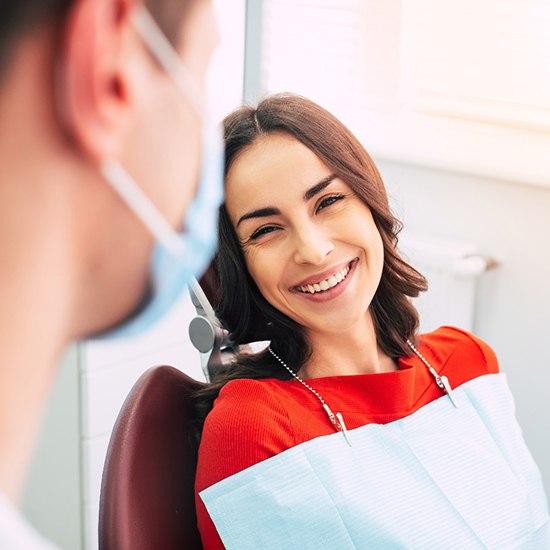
(196, 94, 550, 549)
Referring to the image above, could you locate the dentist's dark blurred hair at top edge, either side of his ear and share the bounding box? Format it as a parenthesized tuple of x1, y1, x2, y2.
(0, 0, 196, 84)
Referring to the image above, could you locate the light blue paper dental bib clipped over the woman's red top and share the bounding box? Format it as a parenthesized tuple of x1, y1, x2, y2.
(200, 374, 550, 550)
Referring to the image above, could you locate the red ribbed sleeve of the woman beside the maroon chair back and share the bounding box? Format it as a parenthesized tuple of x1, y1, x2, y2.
(195, 379, 295, 550)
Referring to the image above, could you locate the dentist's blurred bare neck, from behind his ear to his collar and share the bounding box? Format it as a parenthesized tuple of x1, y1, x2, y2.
(0, 26, 103, 508)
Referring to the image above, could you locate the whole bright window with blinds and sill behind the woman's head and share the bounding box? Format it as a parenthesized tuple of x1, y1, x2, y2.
(253, 0, 550, 186)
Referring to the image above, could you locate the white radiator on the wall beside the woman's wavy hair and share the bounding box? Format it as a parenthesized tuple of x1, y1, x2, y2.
(399, 236, 496, 332)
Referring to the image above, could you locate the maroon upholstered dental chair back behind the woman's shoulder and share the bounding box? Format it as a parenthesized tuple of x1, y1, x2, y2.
(99, 366, 204, 550)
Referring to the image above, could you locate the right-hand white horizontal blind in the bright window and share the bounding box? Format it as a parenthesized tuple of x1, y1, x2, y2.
(400, 0, 550, 129)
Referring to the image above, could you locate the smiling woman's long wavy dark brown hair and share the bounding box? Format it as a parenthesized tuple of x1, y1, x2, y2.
(196, 94, 427, 430)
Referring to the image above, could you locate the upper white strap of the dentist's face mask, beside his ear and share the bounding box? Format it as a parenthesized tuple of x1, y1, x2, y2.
(132, 6, 204, 120)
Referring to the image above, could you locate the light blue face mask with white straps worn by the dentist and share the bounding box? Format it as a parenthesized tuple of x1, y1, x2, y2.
(95, 8, 224, 339)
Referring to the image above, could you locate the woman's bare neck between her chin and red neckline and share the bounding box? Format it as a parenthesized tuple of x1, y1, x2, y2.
(300, 315, 397, 378)
